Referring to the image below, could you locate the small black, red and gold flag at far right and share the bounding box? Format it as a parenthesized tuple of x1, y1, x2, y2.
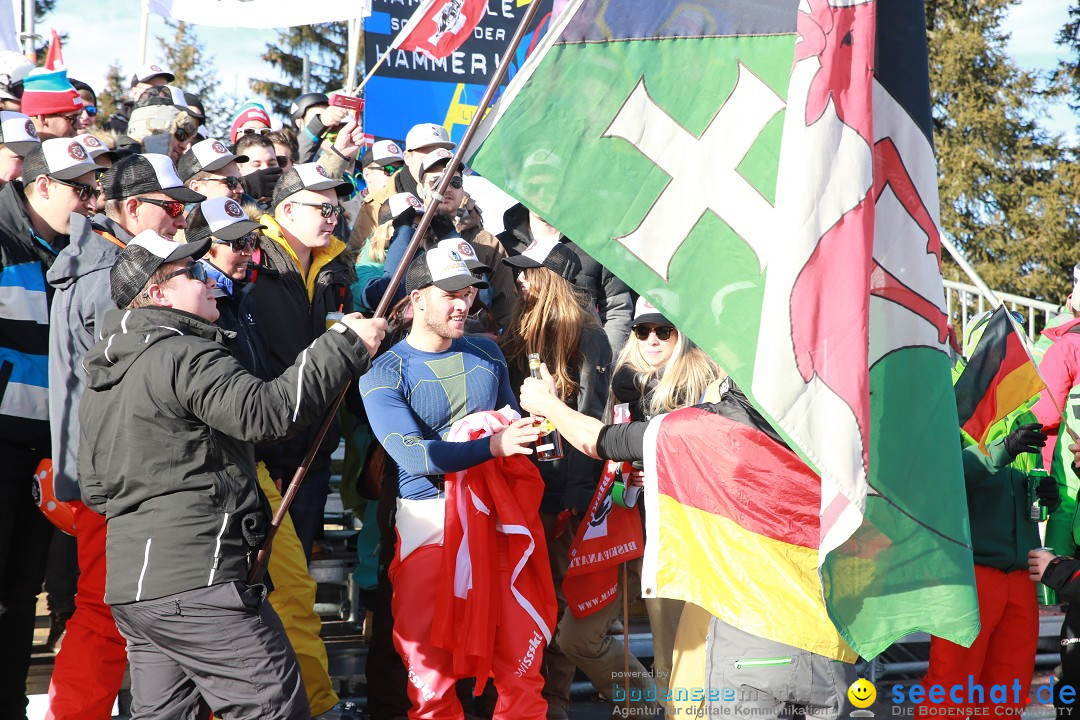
(954, 305, 1047, 452)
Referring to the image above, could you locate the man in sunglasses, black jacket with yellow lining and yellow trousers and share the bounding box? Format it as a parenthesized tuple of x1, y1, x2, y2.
(251, 163, 352, 715)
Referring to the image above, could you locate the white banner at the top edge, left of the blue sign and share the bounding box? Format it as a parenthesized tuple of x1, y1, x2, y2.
(147, 0, 365, 28)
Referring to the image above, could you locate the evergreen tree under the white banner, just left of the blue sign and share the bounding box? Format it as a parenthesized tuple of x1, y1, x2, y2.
(252, 23, 349, 117)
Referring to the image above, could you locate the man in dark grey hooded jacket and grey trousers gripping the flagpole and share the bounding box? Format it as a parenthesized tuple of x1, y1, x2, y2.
(78, 231, 386, 720)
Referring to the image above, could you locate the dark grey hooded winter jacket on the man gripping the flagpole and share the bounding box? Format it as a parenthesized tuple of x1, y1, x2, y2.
(78, 308, 370, 604)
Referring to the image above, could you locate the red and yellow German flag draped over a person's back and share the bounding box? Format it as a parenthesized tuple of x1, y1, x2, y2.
(642, 389, 858, 663)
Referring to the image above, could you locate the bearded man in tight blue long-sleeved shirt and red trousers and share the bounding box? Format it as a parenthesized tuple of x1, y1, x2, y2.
(360, 247, 546, 720)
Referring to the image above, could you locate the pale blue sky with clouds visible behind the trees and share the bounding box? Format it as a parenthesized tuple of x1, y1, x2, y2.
(40, 0, 1077, 134)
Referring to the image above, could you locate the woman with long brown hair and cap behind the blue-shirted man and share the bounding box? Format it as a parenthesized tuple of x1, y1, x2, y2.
(502, 240, 657, 719)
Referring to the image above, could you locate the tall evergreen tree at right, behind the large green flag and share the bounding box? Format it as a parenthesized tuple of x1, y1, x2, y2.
(927, 0, 1080, 301)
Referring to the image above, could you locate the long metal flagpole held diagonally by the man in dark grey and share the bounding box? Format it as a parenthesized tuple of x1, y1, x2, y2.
(247, 0, 540, 583)
